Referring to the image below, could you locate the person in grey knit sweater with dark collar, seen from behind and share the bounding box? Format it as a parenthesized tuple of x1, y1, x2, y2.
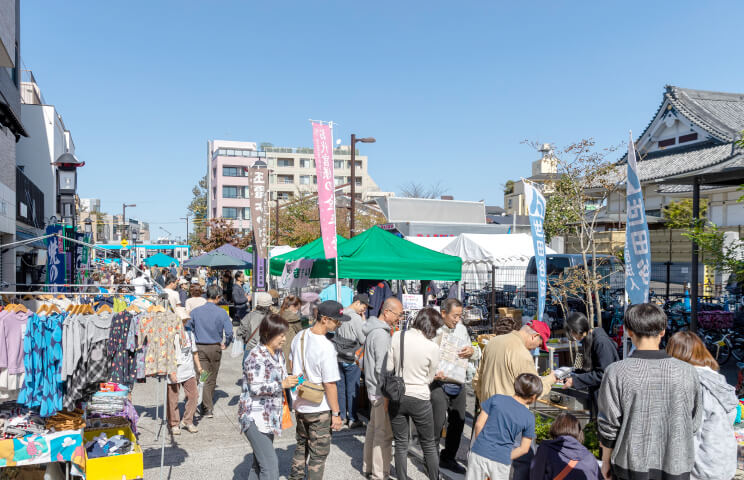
(597, 303, 702, 480)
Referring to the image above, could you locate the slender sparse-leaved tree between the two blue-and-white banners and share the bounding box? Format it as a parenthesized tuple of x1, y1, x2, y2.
(533, 139, 624, 325)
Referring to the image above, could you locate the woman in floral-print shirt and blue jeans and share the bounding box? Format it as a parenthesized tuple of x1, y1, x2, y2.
(238, 314, 297, 480)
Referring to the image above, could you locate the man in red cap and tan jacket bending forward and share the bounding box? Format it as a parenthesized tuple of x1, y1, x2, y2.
(473, 320, 556, 480)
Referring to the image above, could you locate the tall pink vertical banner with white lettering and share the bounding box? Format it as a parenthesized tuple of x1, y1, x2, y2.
(313, 123, 337, 259)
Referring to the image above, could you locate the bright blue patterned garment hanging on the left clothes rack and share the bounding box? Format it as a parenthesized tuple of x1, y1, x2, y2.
(18, 314, 65, 417)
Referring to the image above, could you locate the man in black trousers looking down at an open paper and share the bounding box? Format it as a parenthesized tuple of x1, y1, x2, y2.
(431, 298, 480, 474)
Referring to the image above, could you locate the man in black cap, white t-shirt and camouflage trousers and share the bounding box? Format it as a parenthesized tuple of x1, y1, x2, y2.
(289, 300, 351, 480)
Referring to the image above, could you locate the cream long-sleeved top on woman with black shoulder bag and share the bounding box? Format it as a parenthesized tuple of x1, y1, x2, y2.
(385, 328, 439, 400)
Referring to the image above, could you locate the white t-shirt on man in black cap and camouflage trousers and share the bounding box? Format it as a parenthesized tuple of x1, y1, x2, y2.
(291, 328, 341, 413)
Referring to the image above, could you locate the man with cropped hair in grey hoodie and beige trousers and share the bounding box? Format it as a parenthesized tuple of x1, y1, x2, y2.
(362, 297, 403, 480)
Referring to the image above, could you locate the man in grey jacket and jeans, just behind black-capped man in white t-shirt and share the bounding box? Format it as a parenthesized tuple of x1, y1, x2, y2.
(333, 293, 369, 428)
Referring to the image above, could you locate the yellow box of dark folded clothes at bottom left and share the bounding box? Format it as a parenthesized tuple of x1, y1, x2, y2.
(83, 426, 144, 480)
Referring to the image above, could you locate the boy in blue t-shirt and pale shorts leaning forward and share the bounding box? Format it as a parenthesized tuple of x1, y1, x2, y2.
(465, 373, 543, 480)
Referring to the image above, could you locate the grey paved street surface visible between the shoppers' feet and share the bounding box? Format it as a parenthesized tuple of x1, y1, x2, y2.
(134, 349, 473, 480)
